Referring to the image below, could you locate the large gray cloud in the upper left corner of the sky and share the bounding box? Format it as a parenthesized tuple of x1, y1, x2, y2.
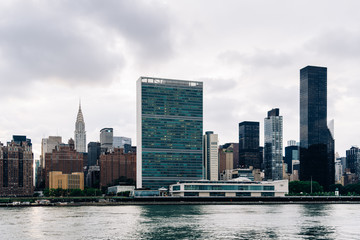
(0, 2, 124, 85)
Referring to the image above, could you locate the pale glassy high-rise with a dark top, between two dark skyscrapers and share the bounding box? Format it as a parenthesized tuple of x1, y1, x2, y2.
(264, 108, 283, 180)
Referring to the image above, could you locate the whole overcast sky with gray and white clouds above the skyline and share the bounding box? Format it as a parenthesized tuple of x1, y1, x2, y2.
(0, 0, 360, 157)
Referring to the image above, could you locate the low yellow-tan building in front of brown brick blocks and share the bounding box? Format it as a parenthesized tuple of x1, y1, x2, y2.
(49, 171, 84, 190)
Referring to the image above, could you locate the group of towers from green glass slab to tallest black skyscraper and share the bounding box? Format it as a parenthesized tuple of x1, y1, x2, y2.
(137, 66, 335, 189)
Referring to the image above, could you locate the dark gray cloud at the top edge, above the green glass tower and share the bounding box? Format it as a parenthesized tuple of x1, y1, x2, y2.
(71, 0, 173, 62)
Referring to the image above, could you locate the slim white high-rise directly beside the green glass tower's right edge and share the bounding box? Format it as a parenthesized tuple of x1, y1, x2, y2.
(204, 131, 219, 181)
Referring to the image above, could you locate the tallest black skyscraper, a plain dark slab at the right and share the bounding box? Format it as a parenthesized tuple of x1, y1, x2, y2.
(300, 66, 335, 190)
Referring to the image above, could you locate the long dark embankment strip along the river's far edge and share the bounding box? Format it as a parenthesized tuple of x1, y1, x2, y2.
(0, 196, 360, 207)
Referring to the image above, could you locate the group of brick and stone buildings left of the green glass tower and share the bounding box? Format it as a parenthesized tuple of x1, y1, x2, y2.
(0, 101, 136, 196)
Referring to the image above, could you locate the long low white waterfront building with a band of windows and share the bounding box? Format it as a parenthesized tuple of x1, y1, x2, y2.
(170, 178, 289, 197)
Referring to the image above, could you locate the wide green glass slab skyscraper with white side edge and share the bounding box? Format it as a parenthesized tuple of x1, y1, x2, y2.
(136, 77, 203, 189)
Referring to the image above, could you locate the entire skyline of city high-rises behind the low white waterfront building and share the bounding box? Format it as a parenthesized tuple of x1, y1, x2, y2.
(0, 66, 360, 195)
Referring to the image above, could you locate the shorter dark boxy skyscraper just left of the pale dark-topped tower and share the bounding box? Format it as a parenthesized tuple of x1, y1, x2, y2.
(239, 122, 262, 169)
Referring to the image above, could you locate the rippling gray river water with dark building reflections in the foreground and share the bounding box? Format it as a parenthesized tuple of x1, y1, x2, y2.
(0, 204, 360, 240)
